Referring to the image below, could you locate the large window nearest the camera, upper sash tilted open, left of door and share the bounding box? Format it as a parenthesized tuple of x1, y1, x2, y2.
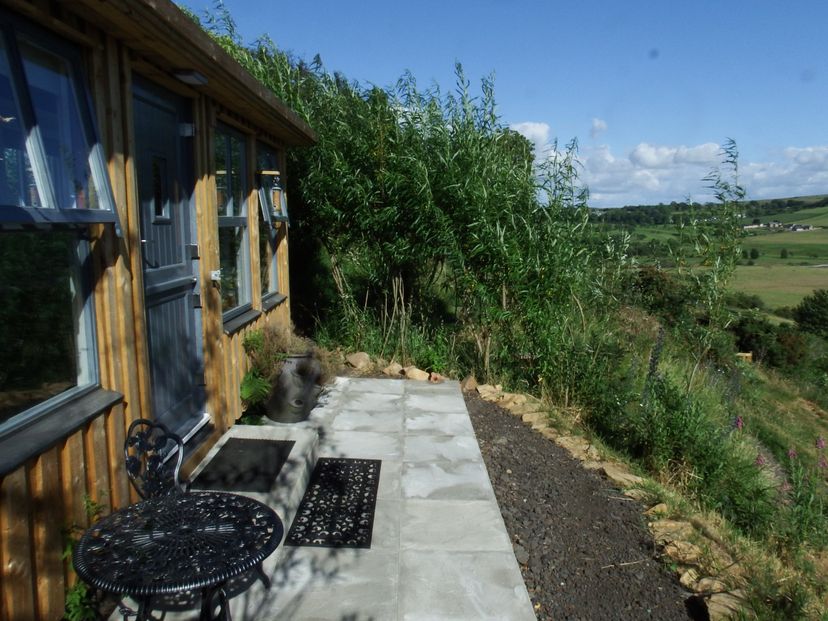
(0, 11, 120, 436)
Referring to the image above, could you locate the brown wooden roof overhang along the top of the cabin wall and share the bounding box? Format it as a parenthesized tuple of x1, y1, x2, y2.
(64, 0, 316, 146)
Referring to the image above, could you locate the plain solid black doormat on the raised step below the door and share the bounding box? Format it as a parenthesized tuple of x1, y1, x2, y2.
(190, 438, 293, 494)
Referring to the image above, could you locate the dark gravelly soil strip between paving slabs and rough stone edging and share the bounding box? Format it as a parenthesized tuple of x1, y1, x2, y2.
(465, 392, 690, 621)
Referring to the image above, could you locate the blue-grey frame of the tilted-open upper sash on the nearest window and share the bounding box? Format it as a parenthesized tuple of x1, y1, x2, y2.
(0, 9, 123, 237)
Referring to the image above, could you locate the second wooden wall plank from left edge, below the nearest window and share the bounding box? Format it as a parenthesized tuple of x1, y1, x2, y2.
(31, 448, 65, 619)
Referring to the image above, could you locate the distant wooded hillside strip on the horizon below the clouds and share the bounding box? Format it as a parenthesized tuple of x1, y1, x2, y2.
(593, 194, 828, 226)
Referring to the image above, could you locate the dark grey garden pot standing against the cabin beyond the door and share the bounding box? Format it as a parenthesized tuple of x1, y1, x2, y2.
(265, 354, 321, 423)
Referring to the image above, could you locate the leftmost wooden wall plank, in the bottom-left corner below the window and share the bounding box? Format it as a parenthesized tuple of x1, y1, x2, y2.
(0, 467, 36, 621)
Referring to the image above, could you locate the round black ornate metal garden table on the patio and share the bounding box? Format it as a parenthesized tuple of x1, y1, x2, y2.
(73, 492, 284, 621)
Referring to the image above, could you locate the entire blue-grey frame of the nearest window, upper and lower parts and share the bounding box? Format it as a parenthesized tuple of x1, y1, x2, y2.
(0, 8, 115, 440)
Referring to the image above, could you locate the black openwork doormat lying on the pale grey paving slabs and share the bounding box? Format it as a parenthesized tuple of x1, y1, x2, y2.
(285, 457, 382, 548)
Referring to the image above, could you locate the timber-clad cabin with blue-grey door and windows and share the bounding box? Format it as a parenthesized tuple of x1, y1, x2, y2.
(0, 0, 315, 621)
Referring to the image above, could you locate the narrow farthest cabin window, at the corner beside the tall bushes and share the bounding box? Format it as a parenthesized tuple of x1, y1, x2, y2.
(256, 144, 287, 301)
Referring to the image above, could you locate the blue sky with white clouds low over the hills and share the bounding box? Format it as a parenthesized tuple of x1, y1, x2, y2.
(182, 0, 828, 207)
